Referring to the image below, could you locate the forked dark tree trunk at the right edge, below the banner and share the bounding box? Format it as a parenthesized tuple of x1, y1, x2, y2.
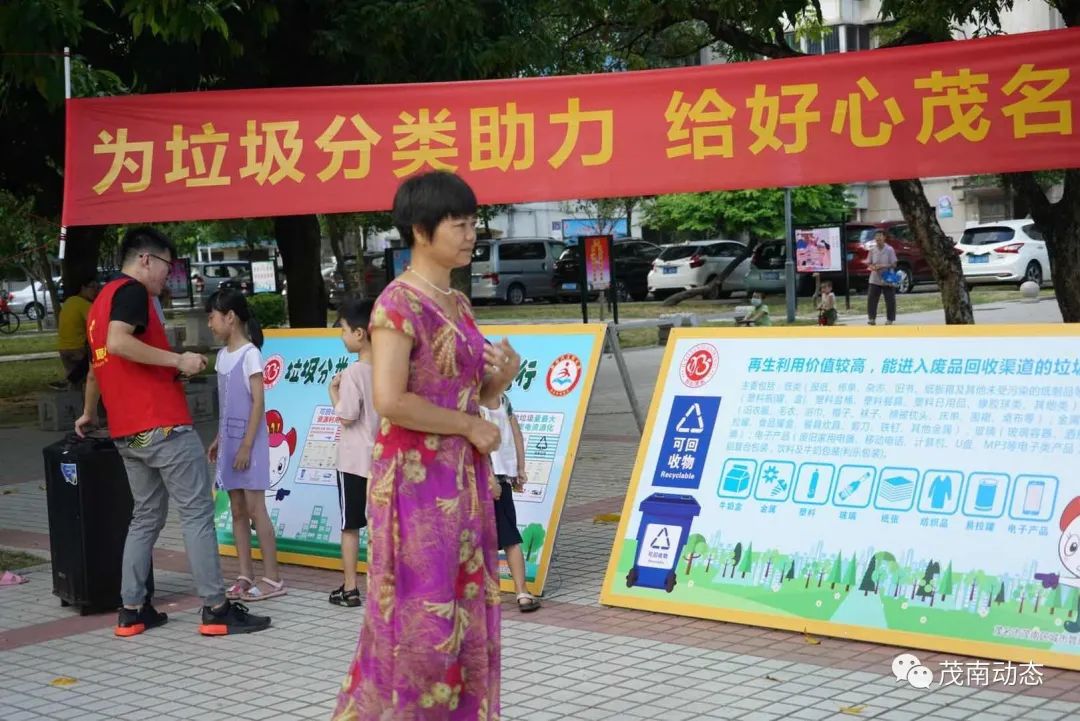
(1004, 169, 1080, 323)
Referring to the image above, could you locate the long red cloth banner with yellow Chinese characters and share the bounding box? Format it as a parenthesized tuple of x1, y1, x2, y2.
(64, 29, 1080, 226)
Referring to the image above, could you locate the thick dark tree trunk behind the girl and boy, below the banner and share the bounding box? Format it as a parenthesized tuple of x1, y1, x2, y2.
(273, 215, 326, 328)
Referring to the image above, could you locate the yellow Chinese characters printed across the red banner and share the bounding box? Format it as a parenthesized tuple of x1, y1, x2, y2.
(90, 63, 1075, 195)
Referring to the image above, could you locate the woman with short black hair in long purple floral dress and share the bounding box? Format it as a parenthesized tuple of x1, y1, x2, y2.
(334, 173, 521, 721)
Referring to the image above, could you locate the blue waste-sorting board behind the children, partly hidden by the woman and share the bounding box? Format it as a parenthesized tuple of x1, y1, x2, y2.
(216, 324, 605, 594)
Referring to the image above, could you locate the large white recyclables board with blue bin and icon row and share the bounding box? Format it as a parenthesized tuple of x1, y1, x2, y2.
(600, 325, 1080, 669)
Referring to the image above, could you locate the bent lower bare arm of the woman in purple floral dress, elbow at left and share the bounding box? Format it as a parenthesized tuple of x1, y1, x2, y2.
(372, 328, 499, 453)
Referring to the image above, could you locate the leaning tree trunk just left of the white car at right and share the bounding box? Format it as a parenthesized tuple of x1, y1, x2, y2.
(889, 178, 975, 325)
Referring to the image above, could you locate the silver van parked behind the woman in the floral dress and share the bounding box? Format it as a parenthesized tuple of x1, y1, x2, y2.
(472, 237, 566, 305)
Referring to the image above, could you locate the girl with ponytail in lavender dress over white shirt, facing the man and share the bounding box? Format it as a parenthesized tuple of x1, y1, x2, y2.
(206, 290, 285, 601)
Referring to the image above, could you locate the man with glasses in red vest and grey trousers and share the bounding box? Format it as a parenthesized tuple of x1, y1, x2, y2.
(75, 228, 270, 636)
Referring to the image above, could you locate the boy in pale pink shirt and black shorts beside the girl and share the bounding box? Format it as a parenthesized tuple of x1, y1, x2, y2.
(329, 297, 379, 607)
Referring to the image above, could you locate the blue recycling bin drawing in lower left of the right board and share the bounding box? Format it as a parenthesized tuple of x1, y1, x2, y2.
(626, 493, 701, 594)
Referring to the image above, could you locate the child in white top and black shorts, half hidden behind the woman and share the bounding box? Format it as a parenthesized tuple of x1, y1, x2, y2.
(480, 379, 540, 613)
